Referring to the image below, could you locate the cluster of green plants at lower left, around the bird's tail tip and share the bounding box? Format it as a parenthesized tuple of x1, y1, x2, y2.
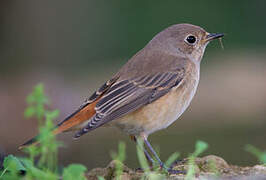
(0, 84, 87, 180)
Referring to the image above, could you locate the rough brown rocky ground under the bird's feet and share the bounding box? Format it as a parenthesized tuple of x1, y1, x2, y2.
(86, 155, 266, 180)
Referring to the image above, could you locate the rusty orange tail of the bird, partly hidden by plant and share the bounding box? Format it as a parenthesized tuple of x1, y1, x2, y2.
(19, 99, 99, 149)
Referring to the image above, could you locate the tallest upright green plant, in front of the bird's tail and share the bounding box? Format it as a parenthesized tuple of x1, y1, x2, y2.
(24, 84, 60, 171)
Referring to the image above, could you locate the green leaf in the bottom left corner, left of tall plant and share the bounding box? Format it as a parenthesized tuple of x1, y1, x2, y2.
(3, 155, 26, 172)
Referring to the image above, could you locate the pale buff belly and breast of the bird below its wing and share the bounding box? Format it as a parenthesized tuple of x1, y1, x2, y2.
(110, 77, 198, 135)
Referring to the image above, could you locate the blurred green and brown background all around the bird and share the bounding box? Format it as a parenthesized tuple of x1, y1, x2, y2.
(0, 0, 266, 168)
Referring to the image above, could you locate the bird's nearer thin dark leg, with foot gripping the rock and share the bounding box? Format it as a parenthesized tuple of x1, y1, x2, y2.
(141, 135, 185, 174)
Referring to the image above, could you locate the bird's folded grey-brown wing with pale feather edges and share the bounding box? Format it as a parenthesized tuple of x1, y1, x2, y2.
(75, 67, 185, 138)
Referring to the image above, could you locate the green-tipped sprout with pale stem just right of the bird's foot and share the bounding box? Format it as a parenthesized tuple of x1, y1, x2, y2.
(185, 141, 208, 180)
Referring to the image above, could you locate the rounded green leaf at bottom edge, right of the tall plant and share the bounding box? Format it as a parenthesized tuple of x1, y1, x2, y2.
(63, 164, 87, 180)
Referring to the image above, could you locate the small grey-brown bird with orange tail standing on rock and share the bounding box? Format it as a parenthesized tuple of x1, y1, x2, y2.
(21, 24, 224, 172)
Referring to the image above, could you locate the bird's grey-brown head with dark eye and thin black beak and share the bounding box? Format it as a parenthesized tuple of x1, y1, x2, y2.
(150, 24, 224, 62)
